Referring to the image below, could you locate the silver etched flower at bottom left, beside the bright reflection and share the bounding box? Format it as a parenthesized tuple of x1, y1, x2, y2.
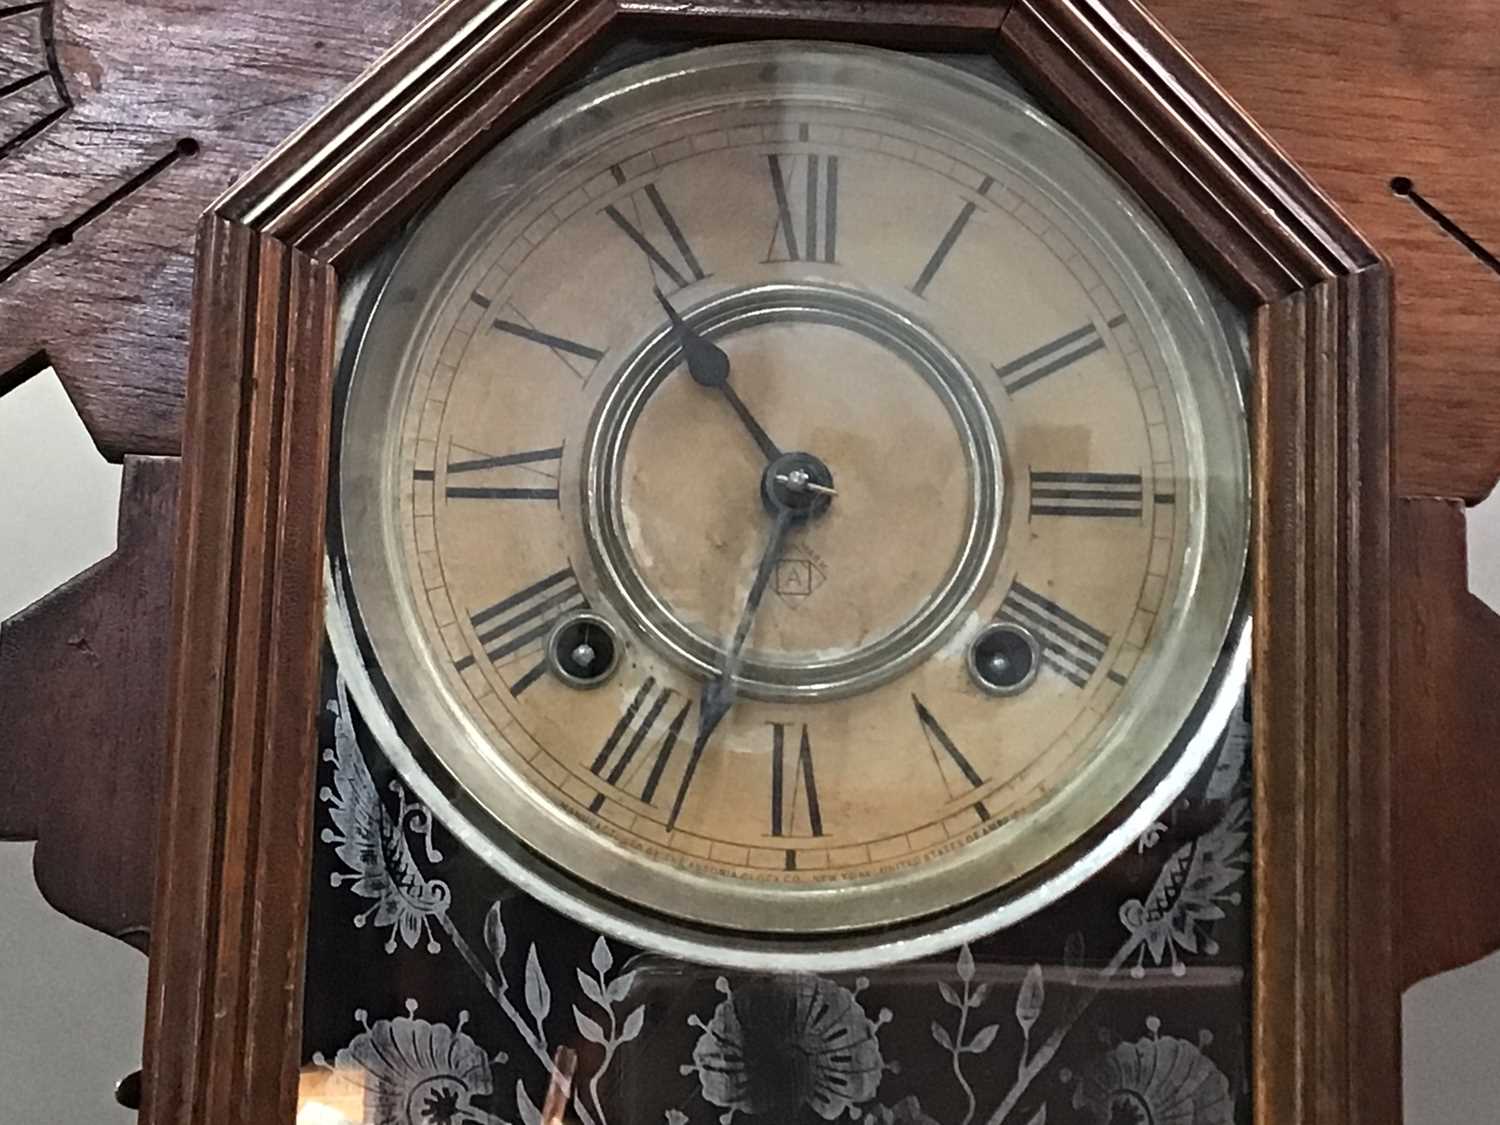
(314, 1001, 504, 1125)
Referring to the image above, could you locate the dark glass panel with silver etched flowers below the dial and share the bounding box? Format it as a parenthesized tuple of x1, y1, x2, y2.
(299, 660, 1250, 1125)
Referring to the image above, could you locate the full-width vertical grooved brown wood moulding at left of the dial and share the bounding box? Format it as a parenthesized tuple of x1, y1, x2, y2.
(144, 216, 338, 1125)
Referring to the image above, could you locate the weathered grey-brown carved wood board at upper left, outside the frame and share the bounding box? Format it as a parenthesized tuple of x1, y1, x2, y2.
(0, 0, 432, 461)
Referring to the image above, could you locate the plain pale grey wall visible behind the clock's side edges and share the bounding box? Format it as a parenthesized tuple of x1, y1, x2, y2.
(0, 372, 1500, 1125)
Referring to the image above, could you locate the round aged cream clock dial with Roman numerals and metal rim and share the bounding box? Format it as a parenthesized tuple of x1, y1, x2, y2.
(342, 45, 1248, 954)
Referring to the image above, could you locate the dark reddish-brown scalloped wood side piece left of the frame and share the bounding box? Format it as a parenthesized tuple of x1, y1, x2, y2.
(0, 458, 177, 950)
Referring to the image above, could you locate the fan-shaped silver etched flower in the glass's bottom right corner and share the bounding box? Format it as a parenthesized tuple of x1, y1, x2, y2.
(1073, 1020, 1235, 1125)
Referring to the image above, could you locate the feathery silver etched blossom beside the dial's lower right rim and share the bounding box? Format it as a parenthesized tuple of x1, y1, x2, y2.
(1121, 798, 1250, 977)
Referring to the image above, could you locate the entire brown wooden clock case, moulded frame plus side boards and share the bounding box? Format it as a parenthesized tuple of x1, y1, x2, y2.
(14, 0, 1500, 1122)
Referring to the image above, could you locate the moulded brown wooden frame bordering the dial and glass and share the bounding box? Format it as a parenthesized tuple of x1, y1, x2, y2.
(144, 0, 1400, 1125)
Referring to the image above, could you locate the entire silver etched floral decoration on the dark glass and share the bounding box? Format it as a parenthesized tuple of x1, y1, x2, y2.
(315, 591, 1250, 1125)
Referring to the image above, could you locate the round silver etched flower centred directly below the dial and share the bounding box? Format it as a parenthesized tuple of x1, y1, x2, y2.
(683, 975, 891, 1124)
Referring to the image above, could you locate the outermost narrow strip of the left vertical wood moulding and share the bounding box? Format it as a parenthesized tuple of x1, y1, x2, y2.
(144, 216, 257, 1125)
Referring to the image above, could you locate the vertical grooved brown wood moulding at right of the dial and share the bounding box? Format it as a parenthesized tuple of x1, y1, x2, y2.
(1253, 266, 1400, 1125)
